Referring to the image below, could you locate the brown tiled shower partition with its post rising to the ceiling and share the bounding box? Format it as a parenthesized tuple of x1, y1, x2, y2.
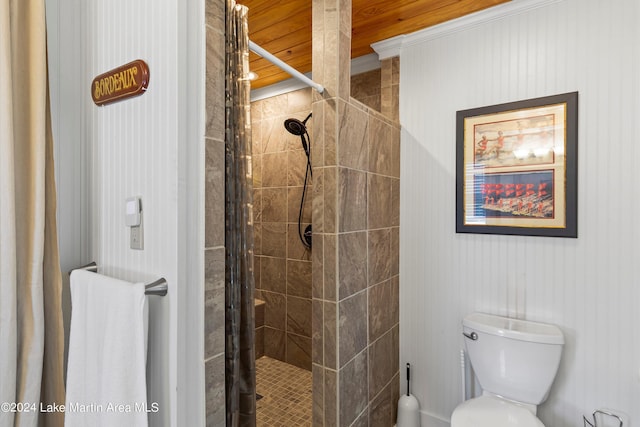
(312, 0, 400, 427)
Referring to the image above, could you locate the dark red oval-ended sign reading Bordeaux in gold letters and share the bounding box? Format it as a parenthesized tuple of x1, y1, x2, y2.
(91, 59, 149, 105)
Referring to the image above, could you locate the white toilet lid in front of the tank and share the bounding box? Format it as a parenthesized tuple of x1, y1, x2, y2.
(451, 396, 544, 427)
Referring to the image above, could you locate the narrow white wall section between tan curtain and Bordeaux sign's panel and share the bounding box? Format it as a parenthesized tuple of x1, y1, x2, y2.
(46, 0, 91, 378)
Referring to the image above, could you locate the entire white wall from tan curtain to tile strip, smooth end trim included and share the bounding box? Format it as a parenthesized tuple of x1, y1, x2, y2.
(47, 0, 204, 426)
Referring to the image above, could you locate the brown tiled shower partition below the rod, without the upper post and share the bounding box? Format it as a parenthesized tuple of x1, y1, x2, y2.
(320, 104, 400, 426)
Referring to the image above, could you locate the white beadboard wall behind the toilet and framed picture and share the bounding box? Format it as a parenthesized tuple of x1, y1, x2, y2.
(400, 0, 640, 427)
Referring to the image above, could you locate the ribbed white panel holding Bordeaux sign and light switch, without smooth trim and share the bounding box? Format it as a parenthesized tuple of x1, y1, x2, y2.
(84, 0, 179, 425)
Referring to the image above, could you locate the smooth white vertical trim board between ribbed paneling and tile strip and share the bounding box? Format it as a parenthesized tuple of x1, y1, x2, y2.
(172, 0, 205, 427)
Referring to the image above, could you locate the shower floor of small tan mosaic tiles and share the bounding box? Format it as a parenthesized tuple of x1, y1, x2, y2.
(256, 356, 311, 427)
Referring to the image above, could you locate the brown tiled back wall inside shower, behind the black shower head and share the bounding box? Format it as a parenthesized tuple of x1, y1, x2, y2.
(251, 89, 314, 370)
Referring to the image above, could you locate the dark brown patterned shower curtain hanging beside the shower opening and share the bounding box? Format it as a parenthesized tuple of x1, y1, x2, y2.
(225, 0, 256, 427)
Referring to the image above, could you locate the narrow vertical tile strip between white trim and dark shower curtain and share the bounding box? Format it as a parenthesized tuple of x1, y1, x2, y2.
(203, 0, 225, 426)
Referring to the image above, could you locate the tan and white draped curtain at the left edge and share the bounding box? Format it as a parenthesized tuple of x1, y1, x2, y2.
(0, 0, 65, 427)
